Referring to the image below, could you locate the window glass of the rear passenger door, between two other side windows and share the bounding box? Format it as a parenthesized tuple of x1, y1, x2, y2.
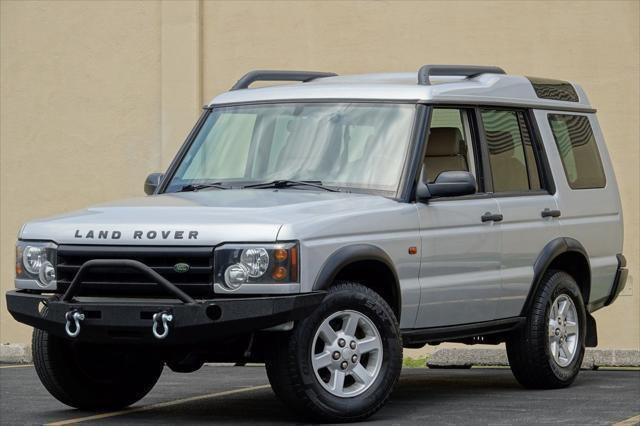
(481, 109, 541, 192)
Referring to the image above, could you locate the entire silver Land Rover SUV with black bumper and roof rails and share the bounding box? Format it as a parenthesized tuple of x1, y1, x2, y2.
(7, 65, 627, 421)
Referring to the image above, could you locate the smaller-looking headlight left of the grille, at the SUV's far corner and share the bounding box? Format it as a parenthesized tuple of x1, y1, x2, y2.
(16, 241, 57, 289)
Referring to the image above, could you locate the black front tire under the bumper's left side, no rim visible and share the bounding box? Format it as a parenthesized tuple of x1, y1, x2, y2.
(32, 329, 164, 410)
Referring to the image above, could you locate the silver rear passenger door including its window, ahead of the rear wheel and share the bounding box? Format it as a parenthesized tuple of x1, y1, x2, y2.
(479, 107, 560, 318)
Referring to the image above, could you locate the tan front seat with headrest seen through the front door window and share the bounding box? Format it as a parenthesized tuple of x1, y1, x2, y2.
(422, 127, 469, 182)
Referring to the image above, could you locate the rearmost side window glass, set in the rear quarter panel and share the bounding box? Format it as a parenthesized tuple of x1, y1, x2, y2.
(549, 114, 607, 189)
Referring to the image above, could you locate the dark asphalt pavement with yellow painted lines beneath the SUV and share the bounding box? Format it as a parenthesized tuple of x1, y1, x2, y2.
(0, 366, 640, 425)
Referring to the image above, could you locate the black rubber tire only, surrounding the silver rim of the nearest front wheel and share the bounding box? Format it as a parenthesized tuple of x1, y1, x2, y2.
(266, 282, 402, 422)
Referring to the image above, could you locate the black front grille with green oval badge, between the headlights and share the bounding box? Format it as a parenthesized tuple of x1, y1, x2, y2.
(56, 245, 213, 297)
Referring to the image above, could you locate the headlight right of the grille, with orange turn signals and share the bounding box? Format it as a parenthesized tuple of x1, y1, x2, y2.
(213, 243, 298, 290)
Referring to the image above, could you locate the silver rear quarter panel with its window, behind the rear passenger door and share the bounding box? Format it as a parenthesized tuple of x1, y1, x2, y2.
(536, 111, 623, 309)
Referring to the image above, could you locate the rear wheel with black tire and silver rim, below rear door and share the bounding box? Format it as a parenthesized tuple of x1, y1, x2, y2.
(507, 270, 586, 389)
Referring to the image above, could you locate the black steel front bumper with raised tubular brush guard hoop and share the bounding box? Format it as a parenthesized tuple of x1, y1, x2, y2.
(7, 259, 325, 345)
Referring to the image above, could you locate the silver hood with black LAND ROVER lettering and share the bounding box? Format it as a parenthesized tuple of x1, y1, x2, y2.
(20, 189, 392, 245)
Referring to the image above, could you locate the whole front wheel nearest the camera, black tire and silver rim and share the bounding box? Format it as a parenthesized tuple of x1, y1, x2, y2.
(266, 283, 402, 422)
